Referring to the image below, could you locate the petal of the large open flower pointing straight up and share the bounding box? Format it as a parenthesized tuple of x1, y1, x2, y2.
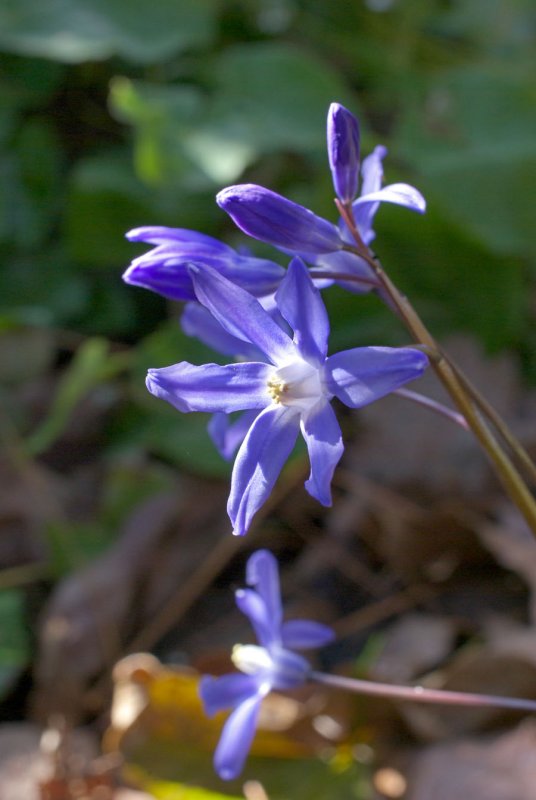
(275, 258, 329, 364)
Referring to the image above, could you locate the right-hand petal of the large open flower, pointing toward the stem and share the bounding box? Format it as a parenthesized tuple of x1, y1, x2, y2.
(326, 347, 428, 408)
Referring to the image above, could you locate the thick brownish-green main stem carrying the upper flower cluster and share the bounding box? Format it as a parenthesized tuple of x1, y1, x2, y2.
(335, 200, 536, 536)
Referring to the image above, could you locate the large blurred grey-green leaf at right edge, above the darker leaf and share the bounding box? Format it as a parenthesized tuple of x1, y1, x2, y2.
(400, 67, 536, 256)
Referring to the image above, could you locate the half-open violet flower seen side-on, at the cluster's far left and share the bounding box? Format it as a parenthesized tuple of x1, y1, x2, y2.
(123, 226, 285, 300)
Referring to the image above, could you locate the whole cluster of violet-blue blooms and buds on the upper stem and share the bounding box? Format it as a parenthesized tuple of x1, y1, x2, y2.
(124, 104, 428, 535)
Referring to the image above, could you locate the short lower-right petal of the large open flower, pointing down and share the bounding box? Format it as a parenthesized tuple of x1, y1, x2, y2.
(301, 402, 344, 506)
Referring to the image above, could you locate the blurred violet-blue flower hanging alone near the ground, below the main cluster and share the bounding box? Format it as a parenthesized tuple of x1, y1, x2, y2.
(200, 550, 334, 780)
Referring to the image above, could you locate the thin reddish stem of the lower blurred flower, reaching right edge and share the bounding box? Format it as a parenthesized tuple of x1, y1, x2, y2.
(310, 672, 536, 711)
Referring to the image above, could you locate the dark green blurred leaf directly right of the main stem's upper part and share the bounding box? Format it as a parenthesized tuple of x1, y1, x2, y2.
(374, 196, 529, 351)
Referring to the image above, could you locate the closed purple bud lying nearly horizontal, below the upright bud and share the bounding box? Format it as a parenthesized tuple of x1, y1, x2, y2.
(216, 183, 343, 254)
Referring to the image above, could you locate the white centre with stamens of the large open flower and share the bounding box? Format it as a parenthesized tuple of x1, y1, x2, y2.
(267, 358, 327, 412)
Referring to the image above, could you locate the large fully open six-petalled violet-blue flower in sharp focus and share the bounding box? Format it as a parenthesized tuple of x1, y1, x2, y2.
(147, 259, 428, 535)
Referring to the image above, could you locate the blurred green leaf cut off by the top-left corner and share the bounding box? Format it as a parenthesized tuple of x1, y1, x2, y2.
(0, 0, 219, 64)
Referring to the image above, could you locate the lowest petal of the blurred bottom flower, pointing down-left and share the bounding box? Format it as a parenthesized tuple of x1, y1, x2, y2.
(214, 684, 270, 781)
